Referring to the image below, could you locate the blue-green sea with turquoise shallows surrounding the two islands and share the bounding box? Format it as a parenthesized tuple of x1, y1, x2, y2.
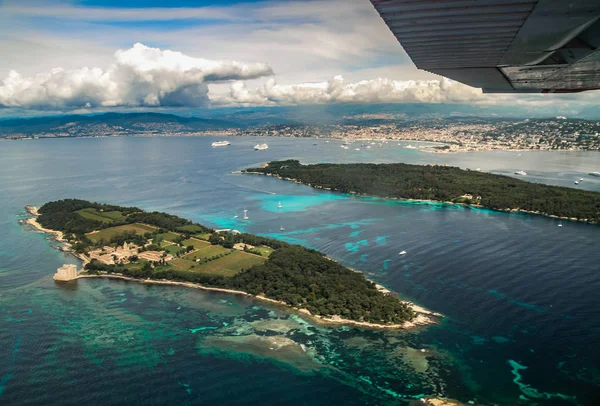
(0, 137, 600, 405)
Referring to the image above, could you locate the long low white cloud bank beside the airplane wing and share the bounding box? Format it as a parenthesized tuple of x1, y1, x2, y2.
(222, 76, 482, 105)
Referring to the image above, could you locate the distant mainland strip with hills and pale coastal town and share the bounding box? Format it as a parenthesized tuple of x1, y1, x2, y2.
(0, 114, 600, 153)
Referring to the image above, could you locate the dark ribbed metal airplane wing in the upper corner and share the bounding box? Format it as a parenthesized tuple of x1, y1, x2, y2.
(370, 0, 600, 93)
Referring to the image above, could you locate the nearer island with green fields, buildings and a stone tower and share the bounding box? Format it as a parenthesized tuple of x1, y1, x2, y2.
(26, 199, 440, 328)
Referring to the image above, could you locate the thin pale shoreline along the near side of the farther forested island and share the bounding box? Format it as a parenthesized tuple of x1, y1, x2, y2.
(238, 170, 597, 224)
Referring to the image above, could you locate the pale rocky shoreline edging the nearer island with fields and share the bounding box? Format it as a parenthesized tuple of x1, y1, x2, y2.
(24, 206, 443, 329)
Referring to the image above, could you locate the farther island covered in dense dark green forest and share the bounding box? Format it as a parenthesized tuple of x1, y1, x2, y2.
(242, 160, 600, 223)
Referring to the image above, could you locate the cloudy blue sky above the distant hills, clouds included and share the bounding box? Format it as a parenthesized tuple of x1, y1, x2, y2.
(0, 0, 600, 117)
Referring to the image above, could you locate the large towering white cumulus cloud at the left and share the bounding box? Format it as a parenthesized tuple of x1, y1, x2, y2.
(0, 43, 273, 109)
